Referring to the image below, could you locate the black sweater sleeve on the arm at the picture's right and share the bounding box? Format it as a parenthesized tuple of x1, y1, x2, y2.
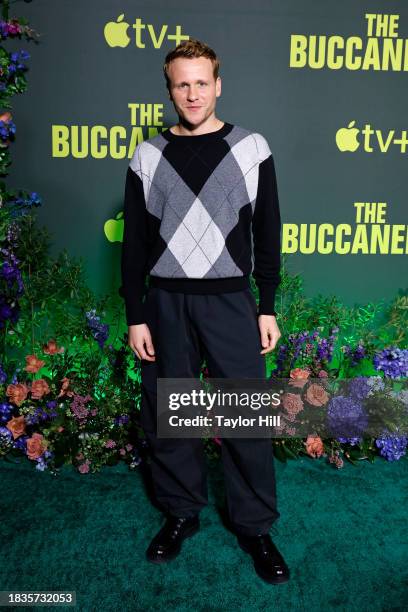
(252, 154, 281, 315)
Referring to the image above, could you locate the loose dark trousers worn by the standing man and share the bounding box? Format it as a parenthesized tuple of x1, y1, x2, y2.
(141, 287, 280, 535)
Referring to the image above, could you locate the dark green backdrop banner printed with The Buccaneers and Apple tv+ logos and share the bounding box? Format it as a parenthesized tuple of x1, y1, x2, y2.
(10, 0, 408, 305)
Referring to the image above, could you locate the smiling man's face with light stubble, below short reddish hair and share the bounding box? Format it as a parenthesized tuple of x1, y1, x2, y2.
(168, 57, 221, 126)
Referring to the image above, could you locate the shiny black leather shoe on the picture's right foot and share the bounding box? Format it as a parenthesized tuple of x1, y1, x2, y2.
(237, 533, 290, 584)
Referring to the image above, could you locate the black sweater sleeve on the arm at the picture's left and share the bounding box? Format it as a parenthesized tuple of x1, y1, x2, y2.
(119, 166, 148, 325)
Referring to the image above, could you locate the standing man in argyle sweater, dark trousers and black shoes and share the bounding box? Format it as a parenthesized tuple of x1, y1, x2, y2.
(120, 39, 289, 583)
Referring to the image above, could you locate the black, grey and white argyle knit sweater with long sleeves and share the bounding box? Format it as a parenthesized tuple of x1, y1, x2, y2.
(119, 122, 281, 325)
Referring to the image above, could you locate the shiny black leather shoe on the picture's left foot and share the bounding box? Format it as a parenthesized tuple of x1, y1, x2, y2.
(146, 515, 200, 563)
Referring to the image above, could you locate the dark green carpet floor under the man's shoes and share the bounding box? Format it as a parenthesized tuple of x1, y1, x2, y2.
(0, 457, 408, 612)
